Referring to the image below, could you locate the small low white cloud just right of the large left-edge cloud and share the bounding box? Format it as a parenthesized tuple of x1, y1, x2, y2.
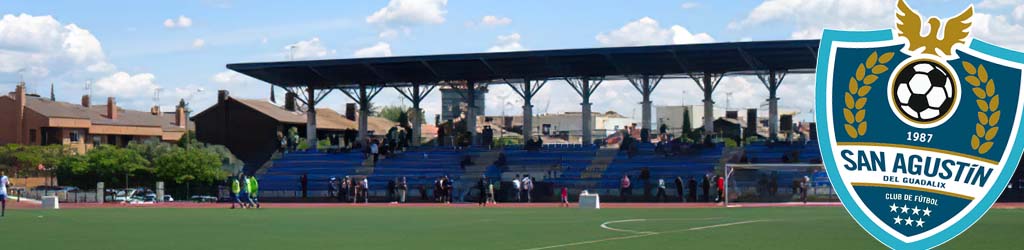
(93, 72, 160, 98)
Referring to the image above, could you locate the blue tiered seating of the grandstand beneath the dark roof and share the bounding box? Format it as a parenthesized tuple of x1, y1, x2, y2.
(259, 141, 821, 201)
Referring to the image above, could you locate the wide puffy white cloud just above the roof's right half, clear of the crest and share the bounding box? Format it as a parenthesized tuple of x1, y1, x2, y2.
(595, 16, 715, 46)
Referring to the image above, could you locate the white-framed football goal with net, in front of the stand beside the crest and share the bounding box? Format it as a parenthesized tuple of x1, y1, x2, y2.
(722, 163, 835, 207)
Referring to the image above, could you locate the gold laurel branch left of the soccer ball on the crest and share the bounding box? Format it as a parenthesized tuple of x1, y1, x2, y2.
(843, 51, 895, 138)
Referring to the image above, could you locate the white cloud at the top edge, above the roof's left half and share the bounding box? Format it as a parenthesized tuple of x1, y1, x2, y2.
(367, 0, 447, 26)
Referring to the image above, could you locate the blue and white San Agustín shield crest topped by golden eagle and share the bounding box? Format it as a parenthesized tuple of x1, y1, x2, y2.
(815, 0, 1024, 249)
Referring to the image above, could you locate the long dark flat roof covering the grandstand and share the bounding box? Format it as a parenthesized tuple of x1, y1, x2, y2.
(227, 40, 818, 89)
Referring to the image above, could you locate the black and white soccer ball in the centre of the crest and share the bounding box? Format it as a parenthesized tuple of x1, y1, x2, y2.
(890, 60, 956, 123)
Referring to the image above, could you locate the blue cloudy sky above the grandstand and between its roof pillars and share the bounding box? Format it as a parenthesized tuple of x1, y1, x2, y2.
(0, 0, 1024, 120)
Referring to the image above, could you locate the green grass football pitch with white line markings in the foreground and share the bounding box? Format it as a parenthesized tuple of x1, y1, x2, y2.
(0, 207, 1024, 250)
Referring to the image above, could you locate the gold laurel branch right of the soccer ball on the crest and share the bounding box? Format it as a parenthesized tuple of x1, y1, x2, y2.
(964, 60, 1000, 154)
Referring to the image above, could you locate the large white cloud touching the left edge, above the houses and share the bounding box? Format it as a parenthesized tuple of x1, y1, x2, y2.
(0, 13, 115, 78)
